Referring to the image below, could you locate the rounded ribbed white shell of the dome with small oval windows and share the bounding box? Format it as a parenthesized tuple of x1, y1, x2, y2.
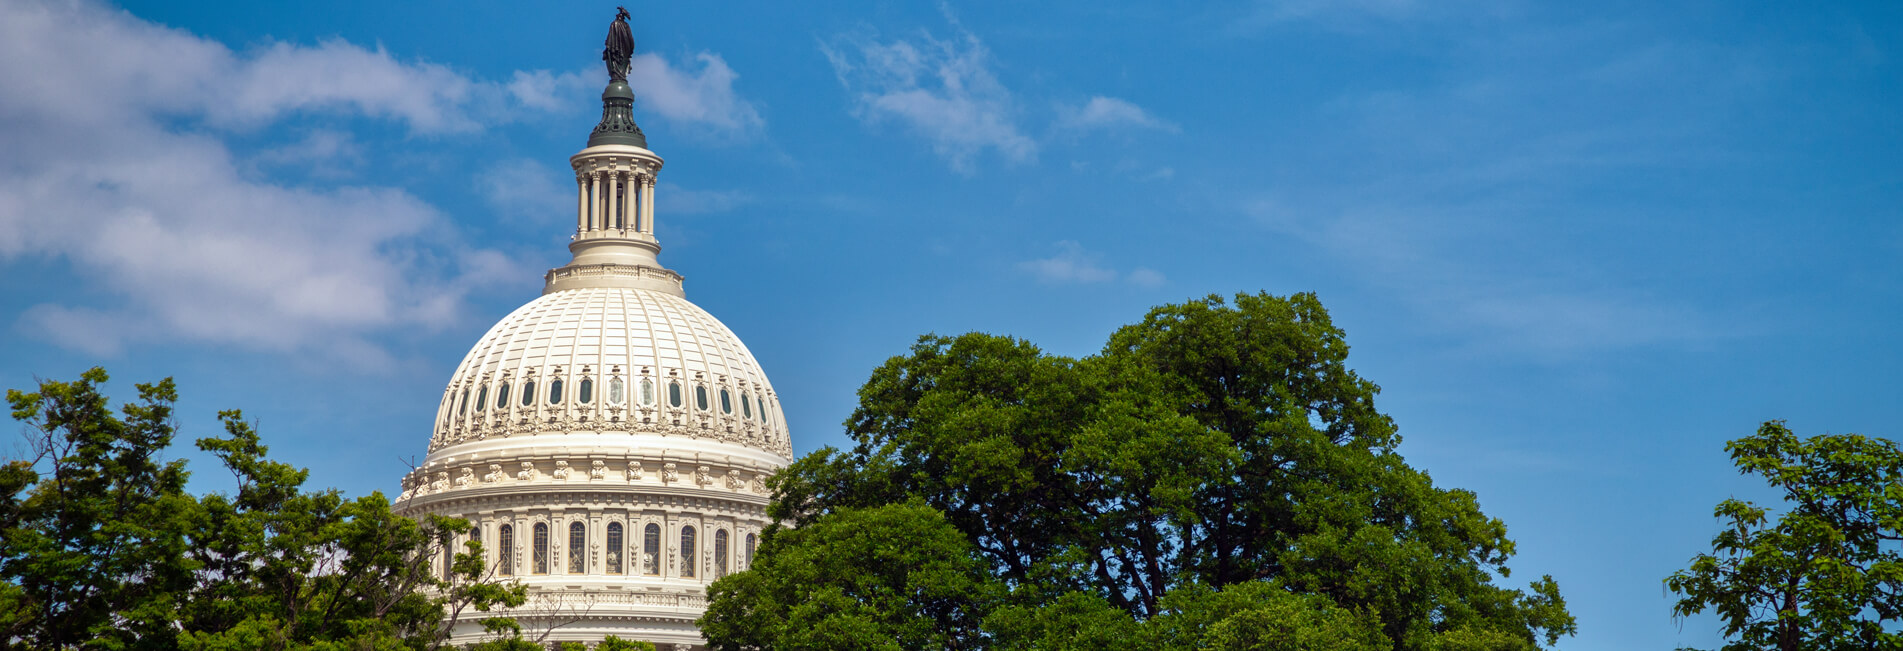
(424, 287, 790, 464)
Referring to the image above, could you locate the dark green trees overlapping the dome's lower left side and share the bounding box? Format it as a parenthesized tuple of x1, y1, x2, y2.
(0, 369, 525, 651)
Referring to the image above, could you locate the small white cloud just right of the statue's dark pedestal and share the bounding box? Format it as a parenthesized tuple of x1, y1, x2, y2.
(628, 51, 767, 135)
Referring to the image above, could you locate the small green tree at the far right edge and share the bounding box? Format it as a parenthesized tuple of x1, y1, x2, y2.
(1665, 421, 1903, 651)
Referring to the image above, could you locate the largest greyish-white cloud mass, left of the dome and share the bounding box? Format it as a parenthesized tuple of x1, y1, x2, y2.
(0, 2, 533, 360)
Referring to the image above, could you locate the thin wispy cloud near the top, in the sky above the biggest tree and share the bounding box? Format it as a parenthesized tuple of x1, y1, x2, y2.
(820, 25, 1037, 173)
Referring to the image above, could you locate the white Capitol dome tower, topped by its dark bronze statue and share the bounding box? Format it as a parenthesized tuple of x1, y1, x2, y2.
(398, 17, 792, 651)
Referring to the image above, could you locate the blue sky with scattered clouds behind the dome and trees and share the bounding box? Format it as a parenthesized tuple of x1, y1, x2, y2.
(0, 0, 1903, 649)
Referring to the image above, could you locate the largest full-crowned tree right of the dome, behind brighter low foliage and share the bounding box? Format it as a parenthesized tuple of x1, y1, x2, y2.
(708, 293, 1574, 649)
